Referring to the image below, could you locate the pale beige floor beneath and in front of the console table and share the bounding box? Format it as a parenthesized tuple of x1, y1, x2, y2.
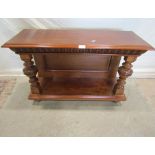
(0, 77, 155, 137)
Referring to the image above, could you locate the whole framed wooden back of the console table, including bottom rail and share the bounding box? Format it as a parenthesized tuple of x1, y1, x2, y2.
(34, 53, 118, 78)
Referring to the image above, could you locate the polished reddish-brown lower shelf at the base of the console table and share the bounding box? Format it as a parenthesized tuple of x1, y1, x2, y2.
(29, 78, 126, 101)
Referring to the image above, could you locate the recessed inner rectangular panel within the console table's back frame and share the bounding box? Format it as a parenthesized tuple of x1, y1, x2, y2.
(43, 53, 111, 71)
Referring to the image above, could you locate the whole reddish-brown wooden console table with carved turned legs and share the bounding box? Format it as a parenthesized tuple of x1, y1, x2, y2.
(2, 29, 153, 101)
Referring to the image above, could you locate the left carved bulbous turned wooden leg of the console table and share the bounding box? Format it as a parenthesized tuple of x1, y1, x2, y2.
(20, 54, 41, 94)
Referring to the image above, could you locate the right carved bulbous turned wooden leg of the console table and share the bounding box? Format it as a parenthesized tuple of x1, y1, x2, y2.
(113, 56, 137, 95)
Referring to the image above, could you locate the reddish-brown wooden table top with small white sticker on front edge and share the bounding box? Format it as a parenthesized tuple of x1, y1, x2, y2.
(2, 29, 154, 50)
